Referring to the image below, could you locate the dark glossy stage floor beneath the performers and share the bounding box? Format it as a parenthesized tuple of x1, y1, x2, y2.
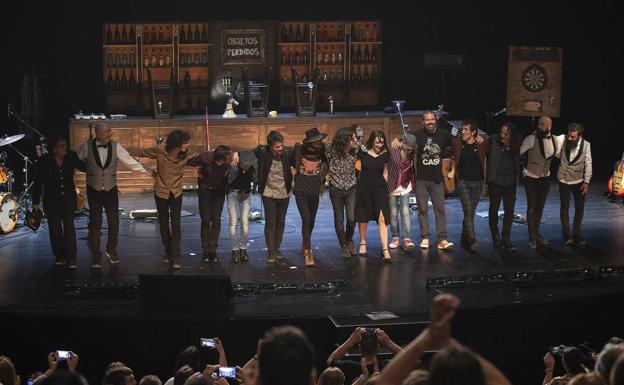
(0, 183, 624, 323)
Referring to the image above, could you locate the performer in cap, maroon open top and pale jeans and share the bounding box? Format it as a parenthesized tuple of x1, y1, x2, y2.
(388, 134, 418, 251)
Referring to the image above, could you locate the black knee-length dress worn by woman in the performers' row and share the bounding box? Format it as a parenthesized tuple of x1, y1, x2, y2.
(355, 151, 390, 223)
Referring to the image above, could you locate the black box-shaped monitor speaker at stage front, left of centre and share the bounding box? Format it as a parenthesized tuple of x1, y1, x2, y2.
(139, 274, 234, 315)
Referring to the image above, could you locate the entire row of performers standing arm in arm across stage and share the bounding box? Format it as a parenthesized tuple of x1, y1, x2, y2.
(33, 111, 592, 269)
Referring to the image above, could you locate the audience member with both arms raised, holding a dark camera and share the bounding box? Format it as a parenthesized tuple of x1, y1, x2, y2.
(327, 327, 402, 384)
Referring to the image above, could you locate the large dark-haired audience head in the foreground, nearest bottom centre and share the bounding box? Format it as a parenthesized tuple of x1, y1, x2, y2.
(256, 326, 316, 385)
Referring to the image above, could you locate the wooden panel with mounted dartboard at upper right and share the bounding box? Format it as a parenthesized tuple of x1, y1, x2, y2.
(507, 46, 563, 118)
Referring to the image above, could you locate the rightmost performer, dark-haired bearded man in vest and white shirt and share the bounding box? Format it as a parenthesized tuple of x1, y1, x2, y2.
(557, 123, 592, 245)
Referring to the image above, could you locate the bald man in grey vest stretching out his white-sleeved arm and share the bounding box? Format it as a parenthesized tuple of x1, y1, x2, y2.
(78, 122, 151, 269)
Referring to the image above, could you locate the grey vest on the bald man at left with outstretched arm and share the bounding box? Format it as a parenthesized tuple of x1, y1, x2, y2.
(86, 140, 117, 191)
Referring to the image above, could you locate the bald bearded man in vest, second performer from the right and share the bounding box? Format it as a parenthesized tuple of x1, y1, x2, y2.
(520, 116, 558, 249)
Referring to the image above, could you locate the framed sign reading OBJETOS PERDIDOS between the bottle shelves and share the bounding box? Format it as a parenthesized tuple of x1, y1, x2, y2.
(221, 29, 266, 65)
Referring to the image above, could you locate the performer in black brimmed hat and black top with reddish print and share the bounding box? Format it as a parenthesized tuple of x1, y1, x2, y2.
(294, 128, 329, 267)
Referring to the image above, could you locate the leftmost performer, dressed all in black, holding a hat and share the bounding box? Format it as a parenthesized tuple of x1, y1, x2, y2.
(31, 136, 86, 270)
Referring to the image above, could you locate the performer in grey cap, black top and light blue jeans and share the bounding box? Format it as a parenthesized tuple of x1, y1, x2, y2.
(227, 151, 258, 262)
